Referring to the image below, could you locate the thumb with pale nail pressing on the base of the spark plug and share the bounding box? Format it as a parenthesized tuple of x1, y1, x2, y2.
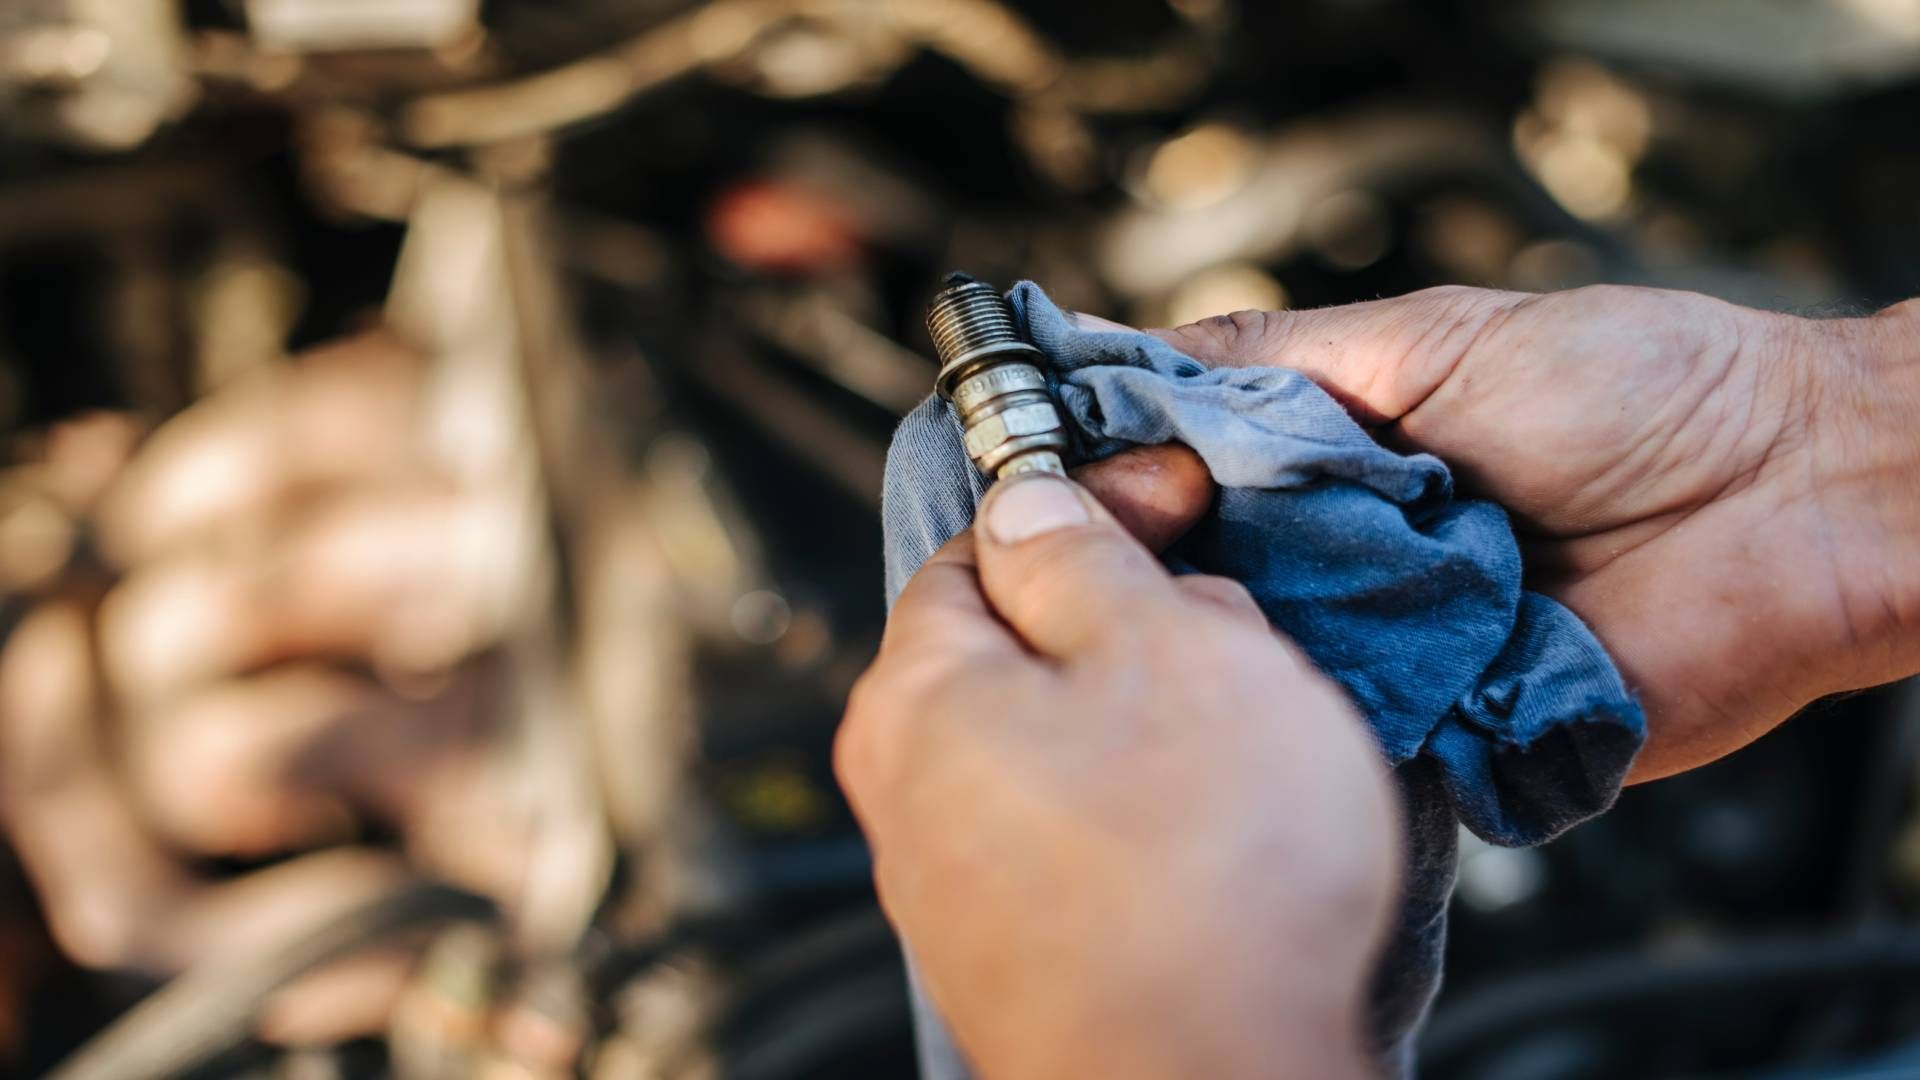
(973, 473, 1183, 659)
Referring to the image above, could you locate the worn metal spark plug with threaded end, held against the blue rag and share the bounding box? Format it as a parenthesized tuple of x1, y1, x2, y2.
(927, 273, 1069, 480)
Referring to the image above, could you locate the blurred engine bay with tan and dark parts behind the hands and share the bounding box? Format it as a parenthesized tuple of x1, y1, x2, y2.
(0, 0, 1920, 1080)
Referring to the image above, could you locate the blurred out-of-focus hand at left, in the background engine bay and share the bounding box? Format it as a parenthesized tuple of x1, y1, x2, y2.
(0, 336, 528, 1042)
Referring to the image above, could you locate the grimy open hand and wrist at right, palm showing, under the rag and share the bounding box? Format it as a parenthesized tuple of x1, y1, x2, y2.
(1113, 286, 1920, 780)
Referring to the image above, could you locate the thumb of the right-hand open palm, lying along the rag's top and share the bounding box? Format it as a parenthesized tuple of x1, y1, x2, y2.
(1148, 284, 1530, 425)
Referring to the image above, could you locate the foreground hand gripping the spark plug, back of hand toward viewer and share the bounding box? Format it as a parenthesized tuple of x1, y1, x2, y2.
(837, 468, 1400, 1080)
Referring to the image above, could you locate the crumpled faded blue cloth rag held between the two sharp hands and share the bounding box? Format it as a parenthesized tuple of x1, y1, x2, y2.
(881, 282, 1645, 1080)
